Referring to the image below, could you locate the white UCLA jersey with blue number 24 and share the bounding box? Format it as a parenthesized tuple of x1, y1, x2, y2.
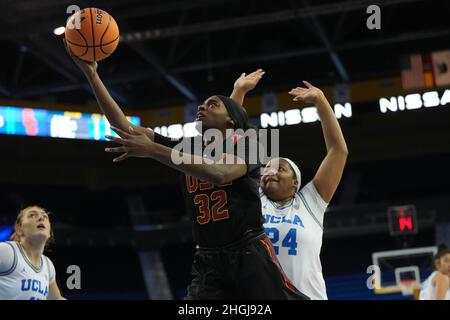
(260, 181, 328, 300)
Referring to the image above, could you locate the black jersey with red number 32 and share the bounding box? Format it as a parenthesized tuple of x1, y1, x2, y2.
(155, 133, 264, 248)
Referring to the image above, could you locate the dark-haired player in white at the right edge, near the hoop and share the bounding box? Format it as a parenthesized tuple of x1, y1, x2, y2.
(419, 245, 450, 300)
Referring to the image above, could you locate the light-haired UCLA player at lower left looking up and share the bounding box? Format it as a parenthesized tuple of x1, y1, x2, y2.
(0, 206, 64, 300)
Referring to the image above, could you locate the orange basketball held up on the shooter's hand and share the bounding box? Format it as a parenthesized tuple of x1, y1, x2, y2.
(65, 8, 119, 62)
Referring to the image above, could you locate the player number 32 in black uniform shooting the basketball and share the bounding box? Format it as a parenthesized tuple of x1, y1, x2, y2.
(66, 40, 308, 300)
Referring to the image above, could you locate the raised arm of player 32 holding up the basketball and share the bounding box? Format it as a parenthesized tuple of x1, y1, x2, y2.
(64, 41, 154, 140)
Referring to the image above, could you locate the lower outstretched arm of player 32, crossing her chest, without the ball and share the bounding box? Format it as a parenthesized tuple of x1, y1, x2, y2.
(105, 127, 247, 185)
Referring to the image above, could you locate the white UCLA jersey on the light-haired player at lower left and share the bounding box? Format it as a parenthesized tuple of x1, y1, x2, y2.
(0, 241, 55, 300)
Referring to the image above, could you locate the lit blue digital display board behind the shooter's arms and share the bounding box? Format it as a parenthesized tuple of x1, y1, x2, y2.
(0, 106, 141, 141)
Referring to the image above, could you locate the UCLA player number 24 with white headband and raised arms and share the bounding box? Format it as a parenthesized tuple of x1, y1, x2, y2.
(232, 70, 348, 300)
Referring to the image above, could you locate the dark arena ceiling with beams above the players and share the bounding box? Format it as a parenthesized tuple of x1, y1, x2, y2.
(0, 0, 450, 110)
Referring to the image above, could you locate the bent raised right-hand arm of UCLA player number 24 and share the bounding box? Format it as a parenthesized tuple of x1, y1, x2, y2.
(289, 81, 348, 203)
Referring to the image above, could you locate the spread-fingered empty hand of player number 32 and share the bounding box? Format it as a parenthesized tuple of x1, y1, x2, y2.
(105, 126, 154, 162)
